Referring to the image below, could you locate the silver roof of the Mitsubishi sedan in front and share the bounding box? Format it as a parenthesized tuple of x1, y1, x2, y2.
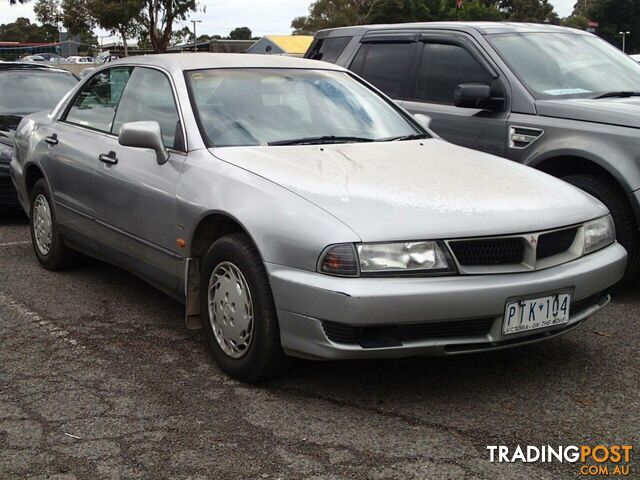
(107, 52, 345, 71)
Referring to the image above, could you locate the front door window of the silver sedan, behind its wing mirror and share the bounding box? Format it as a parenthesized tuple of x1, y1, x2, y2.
(111, 67, 184, 150)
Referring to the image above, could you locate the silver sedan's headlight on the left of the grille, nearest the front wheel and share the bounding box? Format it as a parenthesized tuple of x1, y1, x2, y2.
(319, 241, 456, 277)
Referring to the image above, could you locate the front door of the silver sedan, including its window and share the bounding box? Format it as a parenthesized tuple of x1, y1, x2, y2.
(93, 67, 186, 290)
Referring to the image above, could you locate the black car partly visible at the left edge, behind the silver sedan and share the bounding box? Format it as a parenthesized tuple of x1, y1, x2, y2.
(0, 62, 78, 209)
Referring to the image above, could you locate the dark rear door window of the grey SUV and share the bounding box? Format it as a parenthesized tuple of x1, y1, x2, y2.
(353, 42, 415, 98)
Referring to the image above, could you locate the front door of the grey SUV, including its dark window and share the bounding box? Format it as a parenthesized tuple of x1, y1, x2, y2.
(400, 33, 508, 156)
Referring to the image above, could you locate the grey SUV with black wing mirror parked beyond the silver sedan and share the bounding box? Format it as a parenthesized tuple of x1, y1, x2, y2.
(306, 22, 640, 279)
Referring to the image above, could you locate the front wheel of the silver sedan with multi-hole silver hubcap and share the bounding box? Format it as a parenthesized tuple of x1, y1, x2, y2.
(200, 233, 288, 383)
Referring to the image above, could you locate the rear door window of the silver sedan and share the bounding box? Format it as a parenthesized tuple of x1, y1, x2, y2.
(65, 67, 132, 133)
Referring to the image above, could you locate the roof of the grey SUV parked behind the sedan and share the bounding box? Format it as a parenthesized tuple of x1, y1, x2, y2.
(316, 22, 589, 38)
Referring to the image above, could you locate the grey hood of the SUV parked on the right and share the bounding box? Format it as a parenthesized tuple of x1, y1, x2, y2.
(536, 97, 640, 128)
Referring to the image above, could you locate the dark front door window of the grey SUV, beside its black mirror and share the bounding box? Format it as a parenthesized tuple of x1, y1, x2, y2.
(416, 43, 500, 105)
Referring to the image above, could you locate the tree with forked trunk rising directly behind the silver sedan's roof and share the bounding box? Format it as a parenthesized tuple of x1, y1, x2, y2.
(141, 0, 198, 52)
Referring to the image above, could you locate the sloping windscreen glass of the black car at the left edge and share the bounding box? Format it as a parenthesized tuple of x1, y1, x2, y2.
(0, 68, 78, 115)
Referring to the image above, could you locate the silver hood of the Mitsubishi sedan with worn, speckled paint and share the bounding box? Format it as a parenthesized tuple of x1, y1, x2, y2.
(211, 139, 607, 241)
